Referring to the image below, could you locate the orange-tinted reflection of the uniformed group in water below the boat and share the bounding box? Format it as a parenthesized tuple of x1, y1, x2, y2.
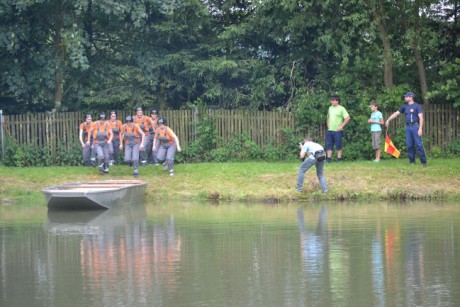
(80, 217, 181, 306)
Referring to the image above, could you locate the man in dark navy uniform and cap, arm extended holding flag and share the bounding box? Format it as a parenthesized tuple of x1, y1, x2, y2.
(385, 92, 426, 167)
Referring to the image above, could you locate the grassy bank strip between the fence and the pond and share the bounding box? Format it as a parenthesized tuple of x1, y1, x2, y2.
(0, 159, 460, 205)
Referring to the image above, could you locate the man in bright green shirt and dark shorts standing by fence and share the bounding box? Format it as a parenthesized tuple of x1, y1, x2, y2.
(326, 96, 350, 163)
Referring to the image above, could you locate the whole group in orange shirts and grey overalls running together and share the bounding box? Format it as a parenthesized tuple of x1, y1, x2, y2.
(79, 107, 181, 177)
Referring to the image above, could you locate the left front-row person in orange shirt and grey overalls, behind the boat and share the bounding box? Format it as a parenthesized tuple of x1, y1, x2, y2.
(88, 112, 113, 174)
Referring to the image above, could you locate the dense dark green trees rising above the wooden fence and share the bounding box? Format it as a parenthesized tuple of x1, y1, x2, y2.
(0, 0, 460, 116)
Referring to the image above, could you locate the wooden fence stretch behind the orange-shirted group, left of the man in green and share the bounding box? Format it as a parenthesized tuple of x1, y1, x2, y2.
(2, 110, 294, 152)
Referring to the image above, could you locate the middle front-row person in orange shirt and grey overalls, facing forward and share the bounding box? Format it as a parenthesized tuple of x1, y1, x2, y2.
(120, 115, 145, 177)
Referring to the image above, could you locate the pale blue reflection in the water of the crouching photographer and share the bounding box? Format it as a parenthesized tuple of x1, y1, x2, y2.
(297, 206, 327, 289)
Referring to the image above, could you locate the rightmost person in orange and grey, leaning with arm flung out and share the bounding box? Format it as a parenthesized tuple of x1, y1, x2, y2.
(152, 118, 182, 176)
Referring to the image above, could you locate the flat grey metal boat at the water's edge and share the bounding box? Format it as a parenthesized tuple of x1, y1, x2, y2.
(43, 180, 147, 210)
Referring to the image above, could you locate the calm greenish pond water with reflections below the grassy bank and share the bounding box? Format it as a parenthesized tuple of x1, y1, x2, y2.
(0, 202, 460, 307)
